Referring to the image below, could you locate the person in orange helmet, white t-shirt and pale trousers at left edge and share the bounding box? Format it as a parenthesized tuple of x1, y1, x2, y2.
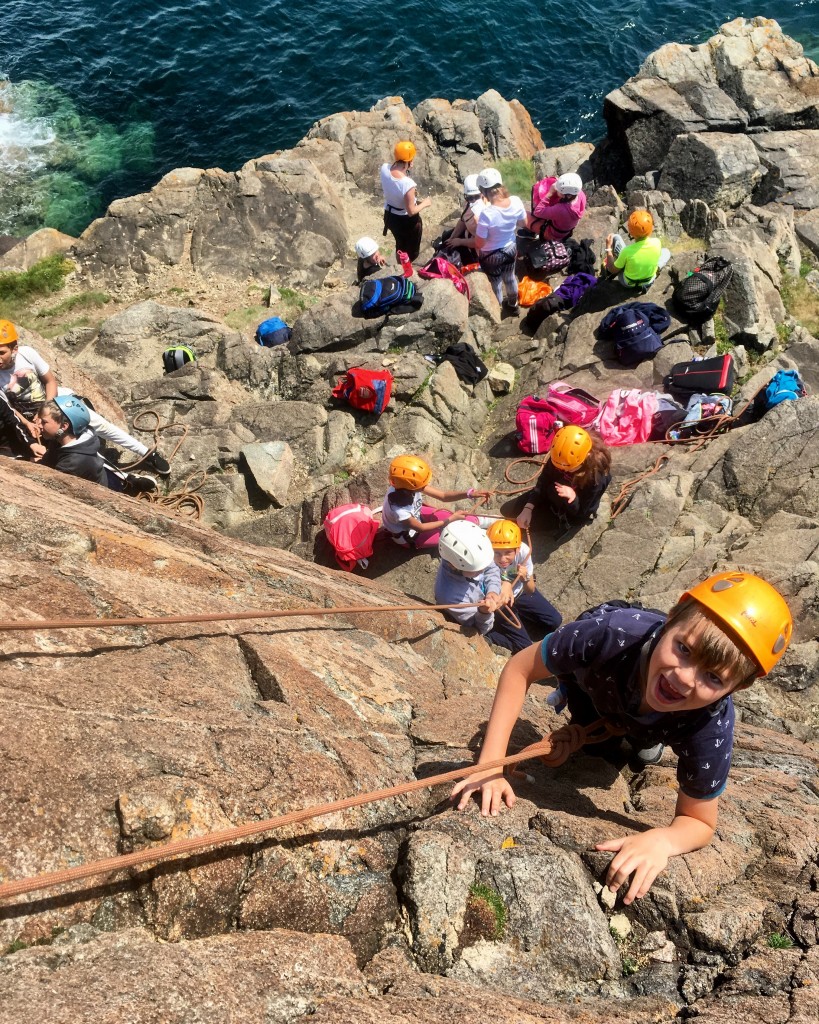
(0, 321, 171, 476)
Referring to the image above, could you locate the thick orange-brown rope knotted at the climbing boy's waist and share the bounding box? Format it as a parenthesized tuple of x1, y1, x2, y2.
(0, 719, 622, 900)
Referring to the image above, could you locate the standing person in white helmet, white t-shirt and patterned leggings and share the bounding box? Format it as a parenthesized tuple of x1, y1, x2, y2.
(450, 167, 527, 312)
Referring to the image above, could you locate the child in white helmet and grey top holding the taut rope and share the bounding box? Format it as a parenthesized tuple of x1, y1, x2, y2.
(435, 521, 508, 649)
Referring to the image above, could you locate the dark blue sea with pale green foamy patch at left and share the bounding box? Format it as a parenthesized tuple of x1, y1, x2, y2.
(0, 0, 819, 233)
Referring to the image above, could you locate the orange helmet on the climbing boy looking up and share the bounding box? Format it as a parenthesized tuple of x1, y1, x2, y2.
(680, 572, 793, 676)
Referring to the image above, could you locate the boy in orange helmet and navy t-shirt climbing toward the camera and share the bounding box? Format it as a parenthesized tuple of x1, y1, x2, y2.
(452, 571, 792, 904)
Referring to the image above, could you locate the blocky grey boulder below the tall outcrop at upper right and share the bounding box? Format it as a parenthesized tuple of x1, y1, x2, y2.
(659, 132, 762, 209)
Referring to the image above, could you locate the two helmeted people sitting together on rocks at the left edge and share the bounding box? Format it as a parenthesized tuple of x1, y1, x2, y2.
(0, 321, 170, 495)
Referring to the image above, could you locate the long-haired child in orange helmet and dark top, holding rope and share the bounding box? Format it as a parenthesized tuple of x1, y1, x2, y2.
(514, 425, 611, 529)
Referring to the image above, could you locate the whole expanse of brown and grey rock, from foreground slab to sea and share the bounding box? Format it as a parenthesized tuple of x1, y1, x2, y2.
(0, 18, 819, 1024)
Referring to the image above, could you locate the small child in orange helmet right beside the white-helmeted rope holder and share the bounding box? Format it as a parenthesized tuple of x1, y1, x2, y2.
(486, 519, 562, 653)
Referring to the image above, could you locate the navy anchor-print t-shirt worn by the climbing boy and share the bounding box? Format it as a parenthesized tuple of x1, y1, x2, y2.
(541, 604, 734, 800)
